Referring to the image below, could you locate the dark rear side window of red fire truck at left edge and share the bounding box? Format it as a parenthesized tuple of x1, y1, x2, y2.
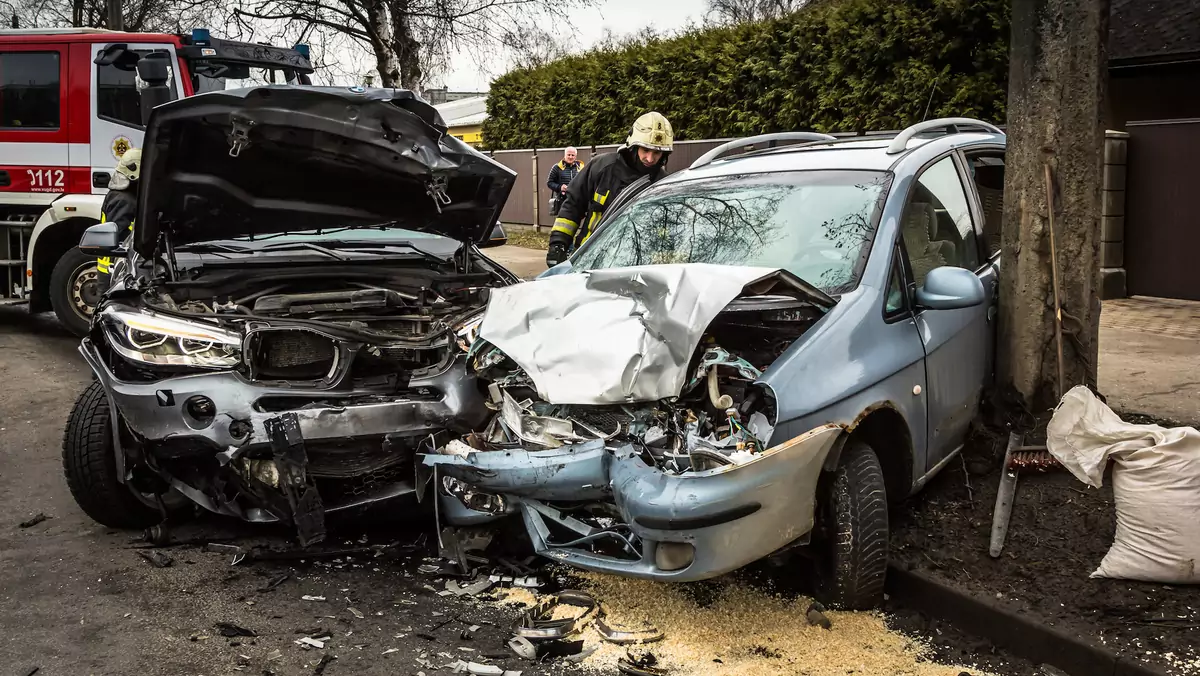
(0, 52, 60, 130)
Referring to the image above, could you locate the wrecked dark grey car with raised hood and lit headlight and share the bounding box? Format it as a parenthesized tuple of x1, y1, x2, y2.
(62, 86, 517, 544)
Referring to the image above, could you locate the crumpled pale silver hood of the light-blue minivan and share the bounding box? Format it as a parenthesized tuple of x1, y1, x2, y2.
(479, 263, 833, 405)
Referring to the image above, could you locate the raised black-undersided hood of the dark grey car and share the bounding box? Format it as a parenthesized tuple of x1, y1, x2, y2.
(133, 85, 516, 256)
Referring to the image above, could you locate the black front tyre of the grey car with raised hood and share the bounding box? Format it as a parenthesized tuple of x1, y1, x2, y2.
(62, 381, 162, 528)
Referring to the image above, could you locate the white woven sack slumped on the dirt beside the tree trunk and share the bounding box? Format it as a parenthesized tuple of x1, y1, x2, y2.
(1046, 385, 1200, 584)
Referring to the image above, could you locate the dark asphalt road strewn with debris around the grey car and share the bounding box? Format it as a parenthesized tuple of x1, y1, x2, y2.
(0, 307, 554, 676)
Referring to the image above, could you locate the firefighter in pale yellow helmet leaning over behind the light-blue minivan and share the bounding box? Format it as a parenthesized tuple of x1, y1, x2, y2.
(546, 112, 674, 268)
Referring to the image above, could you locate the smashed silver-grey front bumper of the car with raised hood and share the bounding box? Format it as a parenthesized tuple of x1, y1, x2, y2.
(79, 340, 488, 542)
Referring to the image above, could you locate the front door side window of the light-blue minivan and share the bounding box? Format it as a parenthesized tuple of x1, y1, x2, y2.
(901, 157, 979, 286)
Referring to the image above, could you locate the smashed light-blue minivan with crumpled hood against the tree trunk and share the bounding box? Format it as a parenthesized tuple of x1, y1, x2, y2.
(419, 119, 1004, 608)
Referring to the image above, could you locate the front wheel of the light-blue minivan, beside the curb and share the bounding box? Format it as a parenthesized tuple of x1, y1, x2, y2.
(814, 438, 888, 610)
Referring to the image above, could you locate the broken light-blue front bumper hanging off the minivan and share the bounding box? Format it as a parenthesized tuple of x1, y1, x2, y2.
(422, 425, 844, 581)
